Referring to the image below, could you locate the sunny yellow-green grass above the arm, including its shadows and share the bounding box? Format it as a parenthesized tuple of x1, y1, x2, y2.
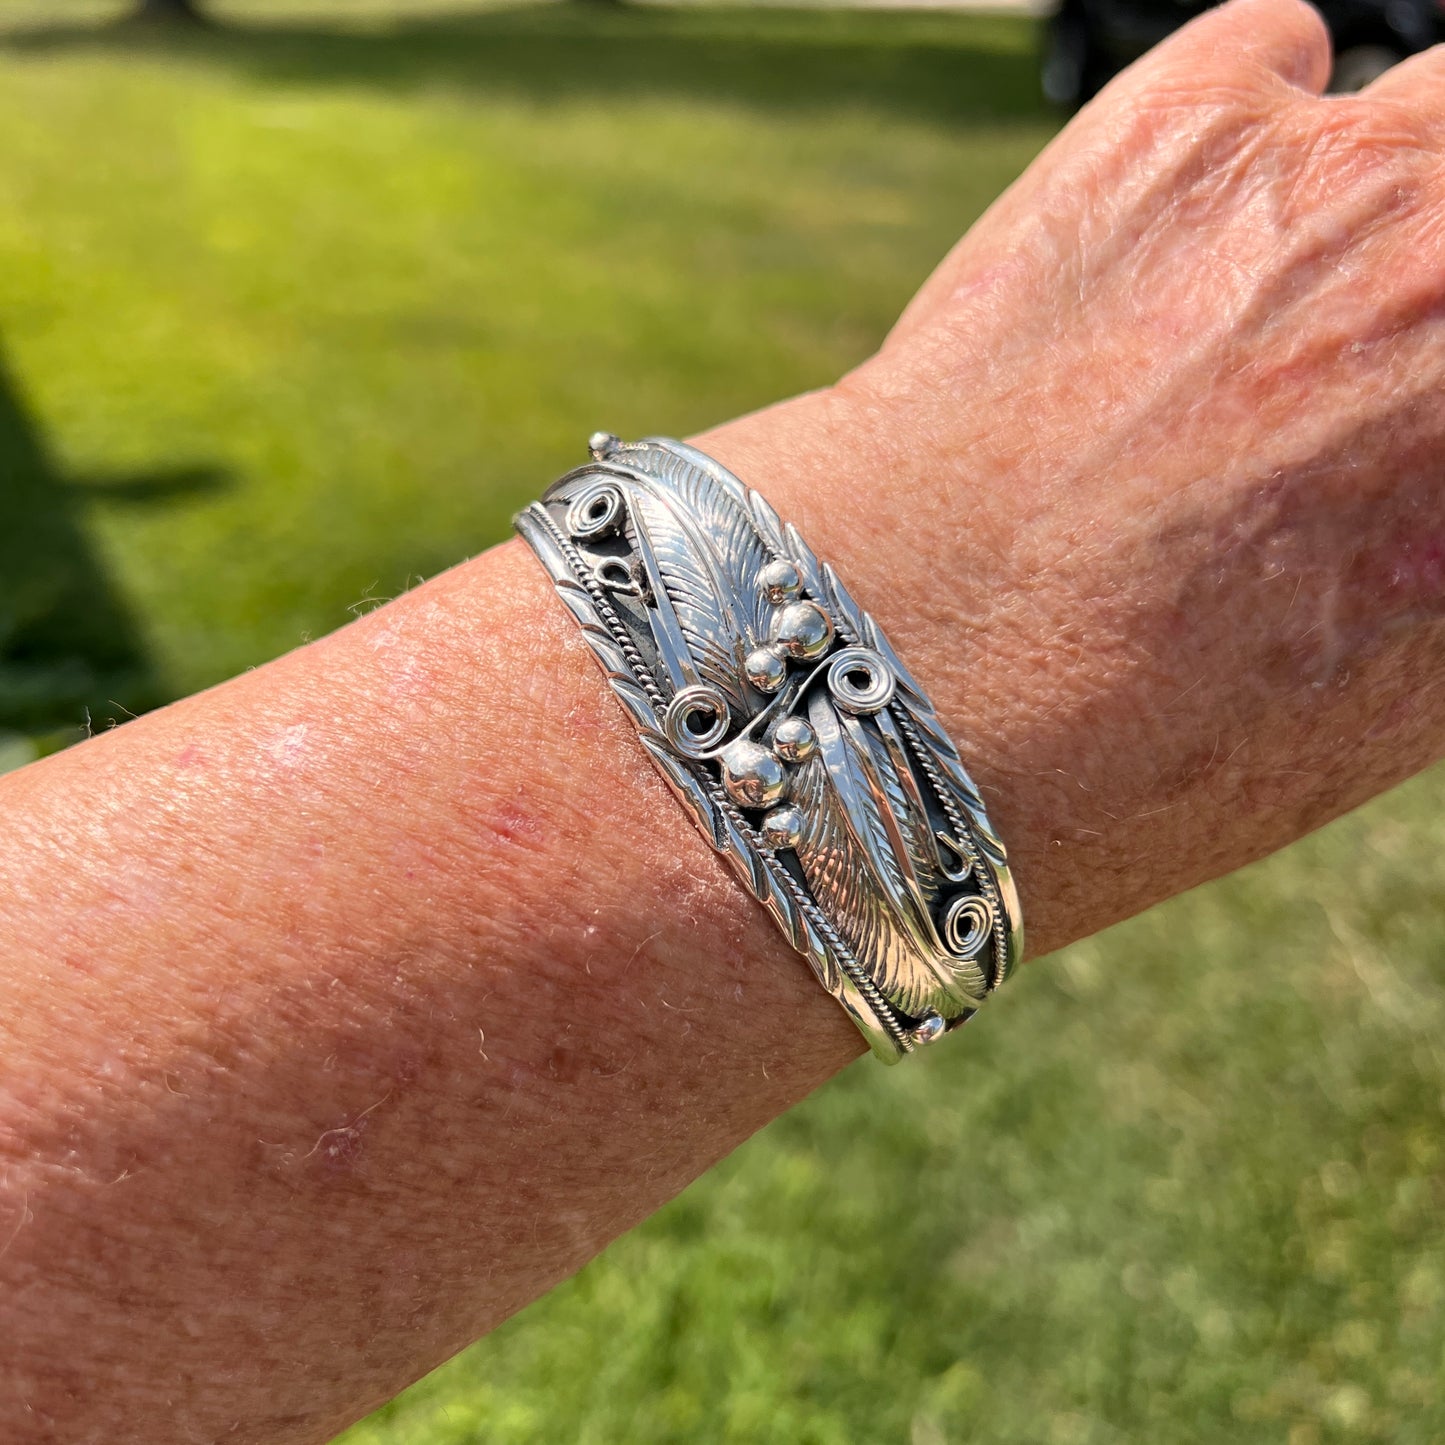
(0, 0, 1049, 731)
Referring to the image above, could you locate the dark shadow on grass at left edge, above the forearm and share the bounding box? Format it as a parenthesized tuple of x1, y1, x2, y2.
(0, 342, 223, 746)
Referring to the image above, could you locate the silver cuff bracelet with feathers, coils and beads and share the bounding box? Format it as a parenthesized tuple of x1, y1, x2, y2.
(516, 434, 1023, 1062)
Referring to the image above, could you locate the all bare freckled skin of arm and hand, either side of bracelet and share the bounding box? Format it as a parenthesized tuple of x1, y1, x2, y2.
(0, 0, 1445, 1445)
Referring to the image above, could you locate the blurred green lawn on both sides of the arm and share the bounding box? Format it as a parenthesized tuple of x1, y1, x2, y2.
(0, 0, 1445, 1445)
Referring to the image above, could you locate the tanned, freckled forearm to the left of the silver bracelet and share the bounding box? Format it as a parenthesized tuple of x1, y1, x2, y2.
(0, 471, 857, 1441)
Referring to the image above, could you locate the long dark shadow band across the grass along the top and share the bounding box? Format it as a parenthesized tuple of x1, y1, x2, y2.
(0, 3, 1046, 121)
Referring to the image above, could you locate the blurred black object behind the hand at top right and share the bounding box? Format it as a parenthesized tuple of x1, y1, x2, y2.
(1043, 0, 1442, 110)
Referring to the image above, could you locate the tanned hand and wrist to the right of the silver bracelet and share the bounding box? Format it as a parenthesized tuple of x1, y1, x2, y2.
(704, 0, 1445, 949)
